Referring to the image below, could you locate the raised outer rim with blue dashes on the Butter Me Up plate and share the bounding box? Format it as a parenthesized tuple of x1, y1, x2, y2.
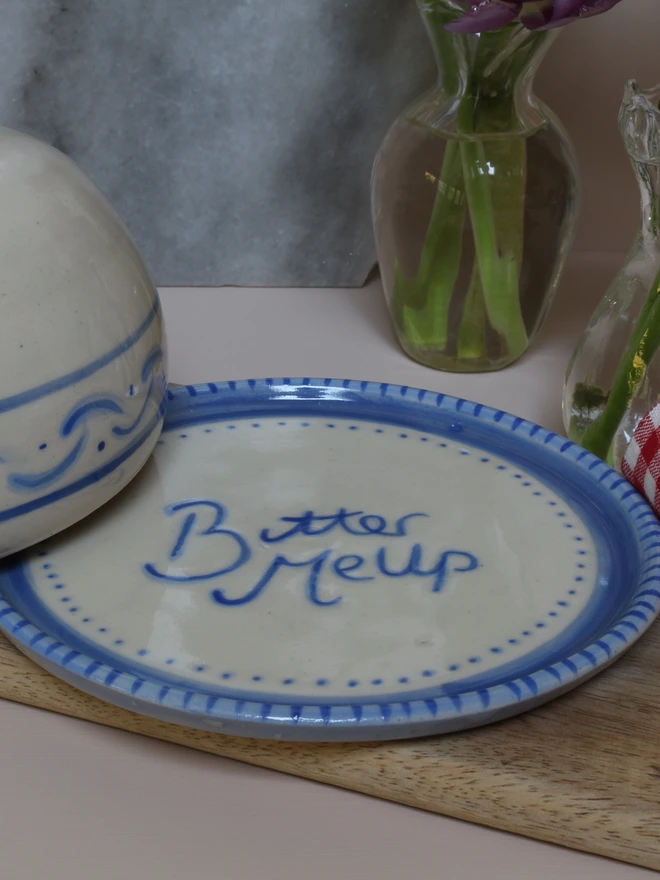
(0, 377, 660, 729)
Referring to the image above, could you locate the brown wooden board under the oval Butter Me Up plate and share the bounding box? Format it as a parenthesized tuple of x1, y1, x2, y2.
(0, 624, 660, 870)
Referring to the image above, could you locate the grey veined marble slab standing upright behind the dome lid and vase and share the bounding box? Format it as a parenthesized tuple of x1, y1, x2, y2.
(0, 0, 433, 286)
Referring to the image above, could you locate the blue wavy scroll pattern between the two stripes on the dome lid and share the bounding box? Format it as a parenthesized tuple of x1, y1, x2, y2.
(7, 346, 164, 492)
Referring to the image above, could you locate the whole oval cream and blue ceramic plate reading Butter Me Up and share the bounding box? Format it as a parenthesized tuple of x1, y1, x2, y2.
(0, 379, 660, 740)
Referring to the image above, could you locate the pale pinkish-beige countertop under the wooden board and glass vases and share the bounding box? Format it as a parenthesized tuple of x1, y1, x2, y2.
(0, 254, 654, 880)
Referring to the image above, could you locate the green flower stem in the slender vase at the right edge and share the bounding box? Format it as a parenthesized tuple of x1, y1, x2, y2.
(580, 264, 660, 459)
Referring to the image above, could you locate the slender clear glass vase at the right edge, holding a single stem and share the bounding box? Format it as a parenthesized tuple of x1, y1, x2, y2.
(563, 81, 660, 470)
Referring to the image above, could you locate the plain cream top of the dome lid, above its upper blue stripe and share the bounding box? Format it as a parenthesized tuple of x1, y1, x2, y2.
(0, 129, 161, 396)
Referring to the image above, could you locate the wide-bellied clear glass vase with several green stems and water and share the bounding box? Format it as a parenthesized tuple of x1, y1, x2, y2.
(372, 0, 579, 372)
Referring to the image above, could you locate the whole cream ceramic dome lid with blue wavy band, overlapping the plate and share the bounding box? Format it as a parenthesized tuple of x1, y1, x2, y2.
(0, 128, 165, 557)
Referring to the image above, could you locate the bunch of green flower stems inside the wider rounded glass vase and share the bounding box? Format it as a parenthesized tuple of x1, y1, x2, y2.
(393, 12, 545, 359)
